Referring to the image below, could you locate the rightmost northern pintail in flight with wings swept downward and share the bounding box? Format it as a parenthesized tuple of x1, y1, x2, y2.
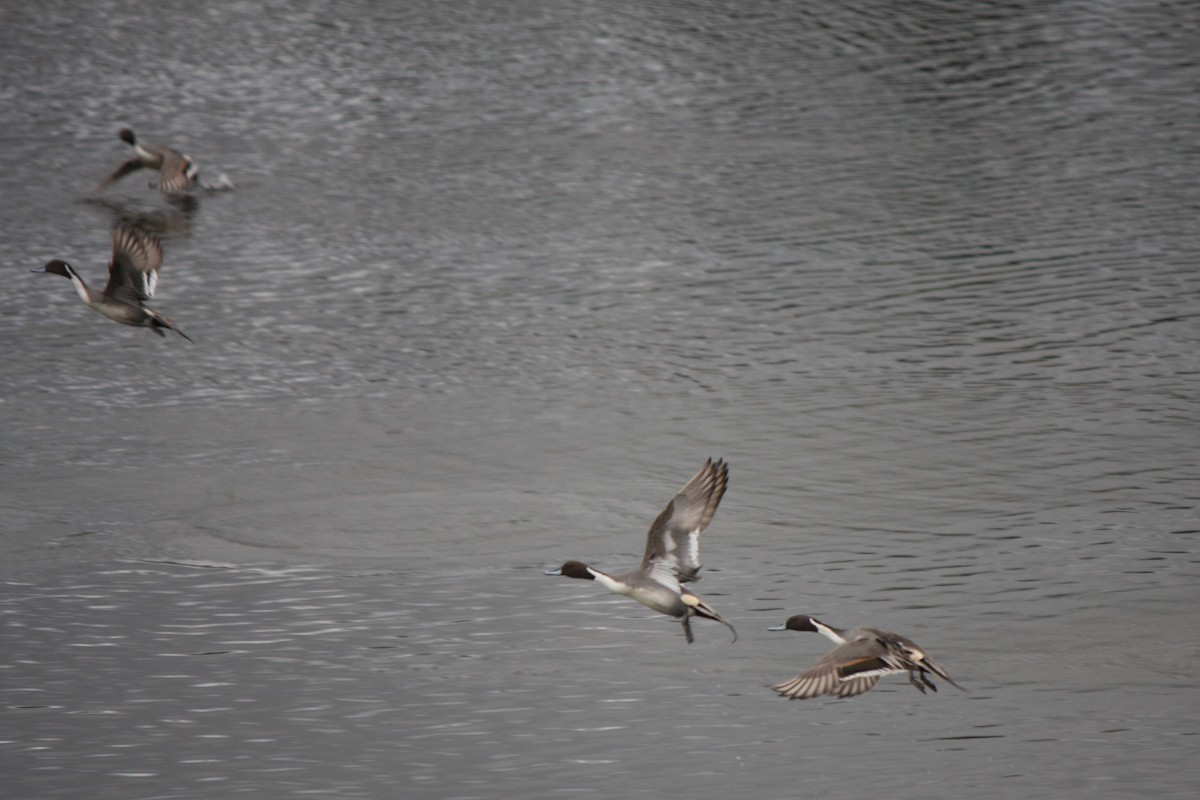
(769, 614, 962, 700)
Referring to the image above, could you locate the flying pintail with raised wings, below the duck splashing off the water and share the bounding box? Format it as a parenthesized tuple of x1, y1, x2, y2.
(30, 222, 194, 344)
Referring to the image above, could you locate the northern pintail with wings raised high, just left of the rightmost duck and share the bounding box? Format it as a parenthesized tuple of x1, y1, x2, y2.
(546, 458, 738, 644)
